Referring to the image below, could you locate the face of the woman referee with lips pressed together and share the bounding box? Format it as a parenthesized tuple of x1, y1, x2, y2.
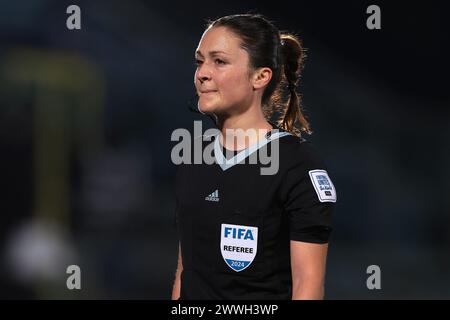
(194, 27, 254, 115)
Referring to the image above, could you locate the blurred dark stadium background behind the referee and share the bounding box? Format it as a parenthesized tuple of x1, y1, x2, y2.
(0, 0, 450, 299)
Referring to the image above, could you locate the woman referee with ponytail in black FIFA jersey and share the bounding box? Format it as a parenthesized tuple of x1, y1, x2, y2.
(172, 14, 336, 299)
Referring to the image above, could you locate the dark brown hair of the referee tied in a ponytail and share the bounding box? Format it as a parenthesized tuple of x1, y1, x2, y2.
(207, 14, 312, 136)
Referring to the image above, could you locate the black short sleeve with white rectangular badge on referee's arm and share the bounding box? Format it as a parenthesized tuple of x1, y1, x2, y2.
(281, 141, 337, 243)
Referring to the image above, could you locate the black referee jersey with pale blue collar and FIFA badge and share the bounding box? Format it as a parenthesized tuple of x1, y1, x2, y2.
(176, 123, 336, 300)
